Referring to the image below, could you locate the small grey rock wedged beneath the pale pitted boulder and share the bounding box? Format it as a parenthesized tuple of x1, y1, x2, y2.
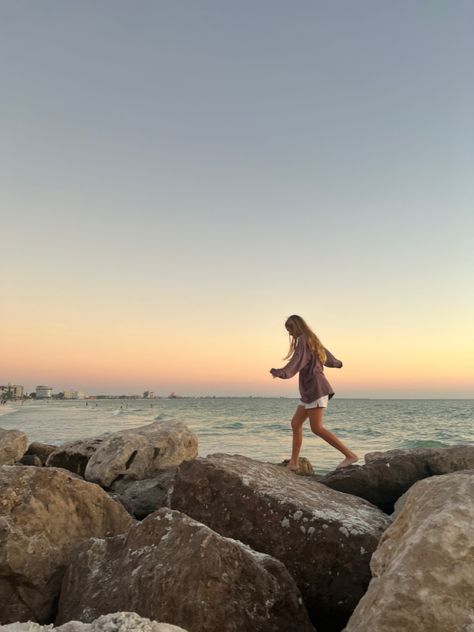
(109, 467, 176, 520)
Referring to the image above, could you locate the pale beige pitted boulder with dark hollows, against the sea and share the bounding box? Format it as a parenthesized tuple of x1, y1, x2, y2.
(85, 421, 198, 487)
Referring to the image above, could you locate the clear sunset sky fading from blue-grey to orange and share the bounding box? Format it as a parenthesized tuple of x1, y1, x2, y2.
(0, 0, 474, 397)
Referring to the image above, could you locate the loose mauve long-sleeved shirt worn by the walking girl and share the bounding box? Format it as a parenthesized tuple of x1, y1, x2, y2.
(270, 335, 342, 404)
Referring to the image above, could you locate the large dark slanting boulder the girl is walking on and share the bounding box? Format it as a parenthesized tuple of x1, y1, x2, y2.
(171, 454, 390, 632)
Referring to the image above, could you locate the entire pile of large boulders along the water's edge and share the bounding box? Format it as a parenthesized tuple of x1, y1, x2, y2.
(0, 422, 474, 632)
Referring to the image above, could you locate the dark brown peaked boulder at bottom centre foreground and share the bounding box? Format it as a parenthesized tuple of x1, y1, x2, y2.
(56, 508, 313, 632)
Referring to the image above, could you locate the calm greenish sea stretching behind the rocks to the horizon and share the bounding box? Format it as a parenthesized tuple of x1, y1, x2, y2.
(0, 397, 474, 473)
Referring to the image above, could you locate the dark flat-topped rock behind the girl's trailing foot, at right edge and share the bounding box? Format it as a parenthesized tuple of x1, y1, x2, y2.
(320, 445, 474, 513)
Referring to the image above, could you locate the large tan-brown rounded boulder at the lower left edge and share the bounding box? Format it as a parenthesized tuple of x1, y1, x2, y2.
(0, 466, 133, 623)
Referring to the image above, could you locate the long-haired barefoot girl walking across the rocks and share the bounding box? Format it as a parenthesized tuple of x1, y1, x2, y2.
(270, 314, 359, 471)
